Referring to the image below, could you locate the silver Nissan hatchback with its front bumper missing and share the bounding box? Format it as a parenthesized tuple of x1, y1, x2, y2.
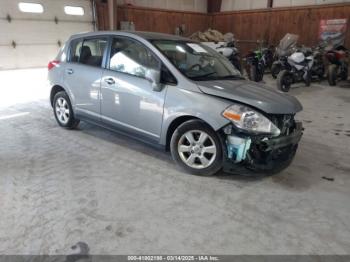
(48, 31, 302, 175)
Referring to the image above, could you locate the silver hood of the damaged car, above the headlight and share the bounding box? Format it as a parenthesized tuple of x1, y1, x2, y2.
(197, 80, 303, 114)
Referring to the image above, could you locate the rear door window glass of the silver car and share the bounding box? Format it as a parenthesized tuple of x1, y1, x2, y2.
(70, 38, 107, 67)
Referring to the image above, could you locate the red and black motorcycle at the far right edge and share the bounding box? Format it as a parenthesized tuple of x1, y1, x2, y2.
(325, 46, 349, 86)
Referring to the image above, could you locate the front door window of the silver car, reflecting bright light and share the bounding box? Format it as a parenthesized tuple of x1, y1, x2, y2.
(109, 37, 160, 78)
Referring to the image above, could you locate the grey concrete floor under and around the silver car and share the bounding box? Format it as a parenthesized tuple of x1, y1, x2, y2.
(0, 69, 350, 254)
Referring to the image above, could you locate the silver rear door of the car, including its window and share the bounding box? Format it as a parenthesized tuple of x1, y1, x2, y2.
(64, 36, 108, 120)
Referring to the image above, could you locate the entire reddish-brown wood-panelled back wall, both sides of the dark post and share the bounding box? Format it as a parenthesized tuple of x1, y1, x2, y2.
(96, 0, 350, 54)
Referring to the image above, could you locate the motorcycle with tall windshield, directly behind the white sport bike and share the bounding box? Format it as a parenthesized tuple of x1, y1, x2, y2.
(271, 33, 299, 79)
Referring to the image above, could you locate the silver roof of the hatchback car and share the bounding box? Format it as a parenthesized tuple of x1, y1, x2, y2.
(72, 31, 193, 41)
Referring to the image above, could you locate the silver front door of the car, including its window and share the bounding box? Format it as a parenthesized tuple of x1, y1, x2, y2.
(101, 37, 166, 141)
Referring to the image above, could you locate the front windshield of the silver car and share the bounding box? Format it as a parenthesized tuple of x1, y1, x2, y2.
(152, 40, 242, 81)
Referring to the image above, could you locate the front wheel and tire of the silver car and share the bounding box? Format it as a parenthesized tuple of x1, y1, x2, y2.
(170, 120, 223, 176)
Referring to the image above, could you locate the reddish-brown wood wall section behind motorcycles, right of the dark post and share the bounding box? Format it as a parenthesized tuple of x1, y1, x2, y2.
(212, 4, 350, 54)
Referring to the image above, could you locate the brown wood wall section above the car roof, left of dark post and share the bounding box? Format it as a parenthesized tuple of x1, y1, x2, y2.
(117, 6, 211, 35)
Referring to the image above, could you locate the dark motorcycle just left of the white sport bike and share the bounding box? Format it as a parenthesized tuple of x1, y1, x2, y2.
(245, 45, 273, 82)
